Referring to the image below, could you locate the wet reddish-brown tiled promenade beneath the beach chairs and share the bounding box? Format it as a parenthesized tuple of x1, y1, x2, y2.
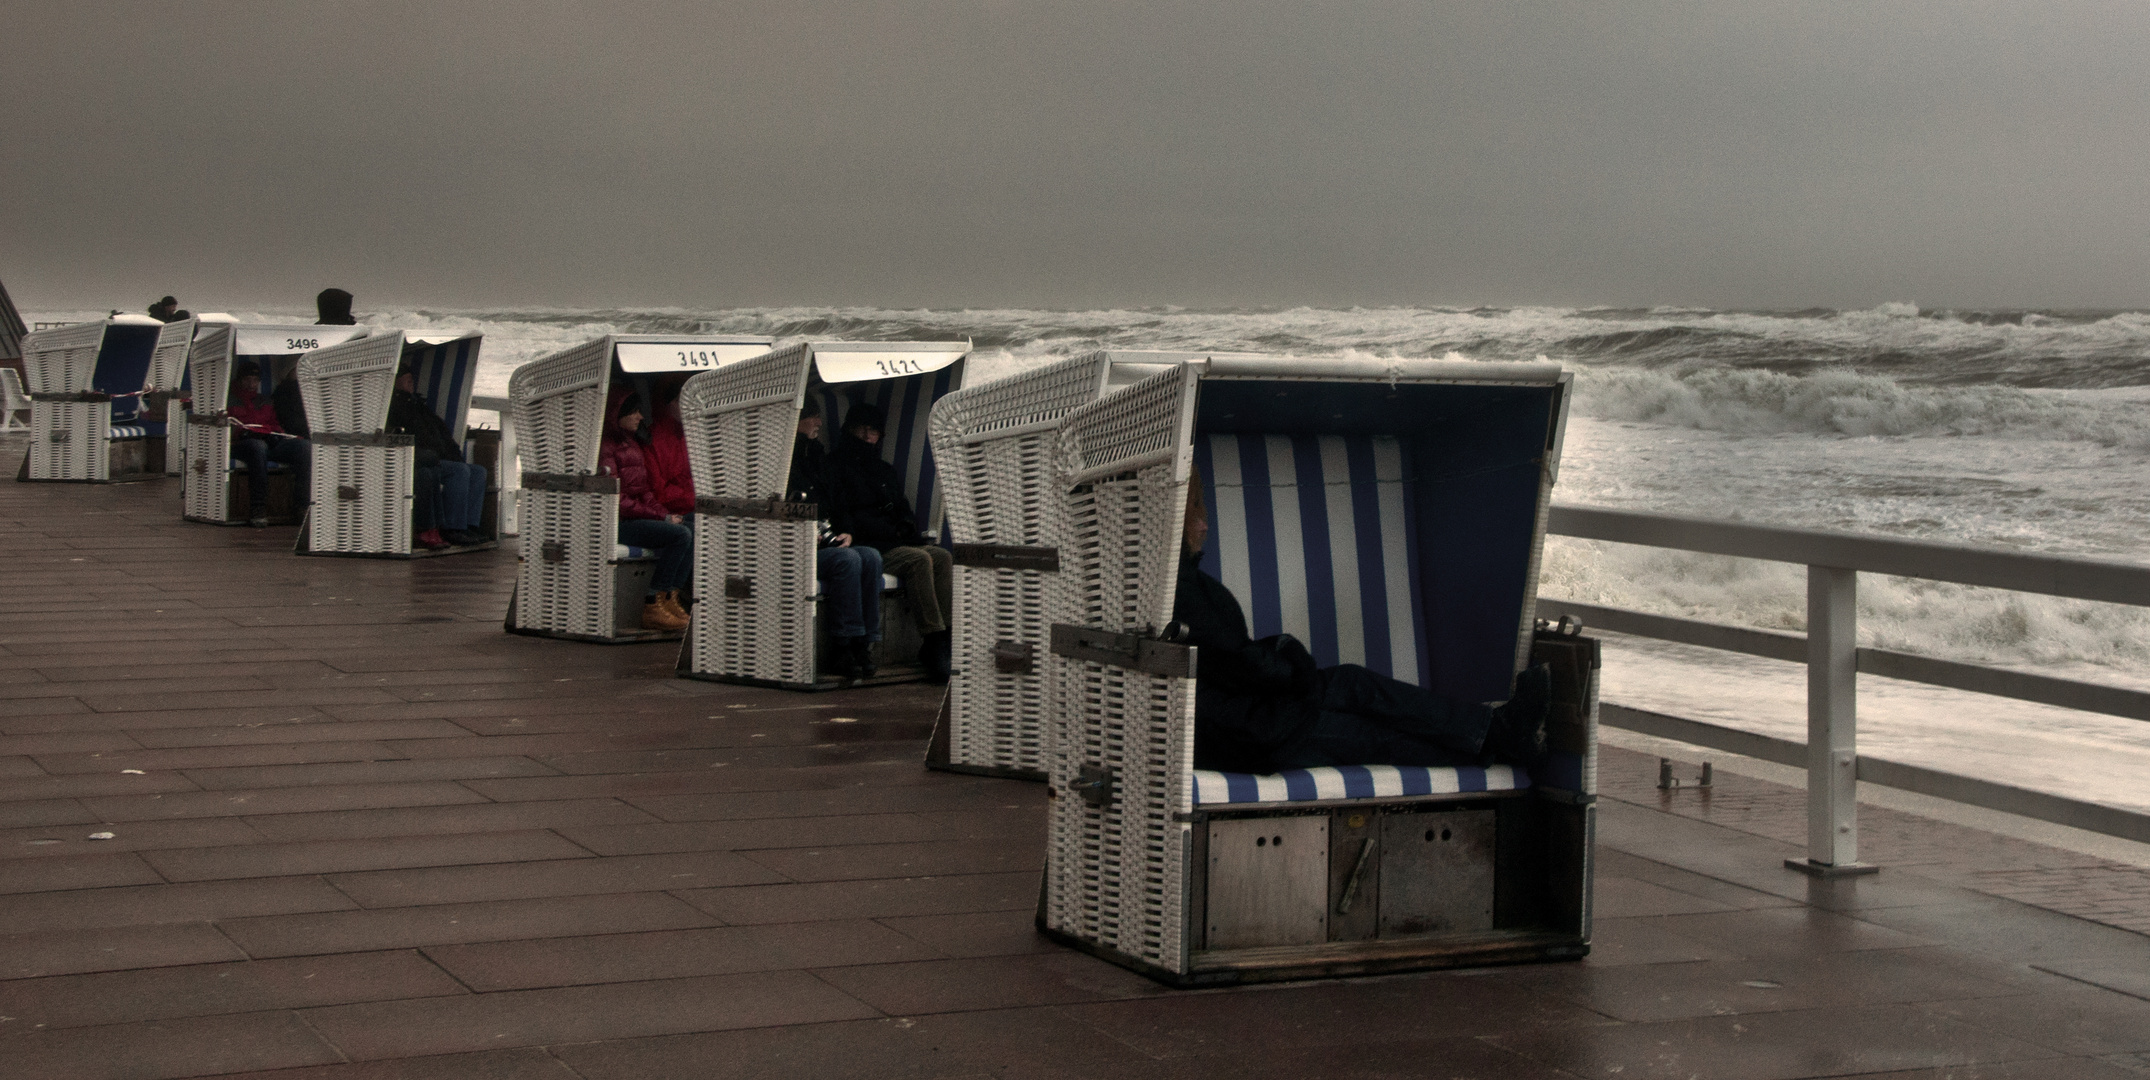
(0, 439, 2150, 1080)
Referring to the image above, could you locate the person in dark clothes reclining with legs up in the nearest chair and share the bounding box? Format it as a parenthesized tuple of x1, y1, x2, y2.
(1172, 466, 1552, 775)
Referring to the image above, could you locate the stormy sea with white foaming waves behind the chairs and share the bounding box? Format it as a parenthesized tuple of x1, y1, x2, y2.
(26, 303, 2150, 809)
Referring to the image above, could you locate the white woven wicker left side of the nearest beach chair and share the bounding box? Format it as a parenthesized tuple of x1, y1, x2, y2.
(1045, 370, 1193, 972)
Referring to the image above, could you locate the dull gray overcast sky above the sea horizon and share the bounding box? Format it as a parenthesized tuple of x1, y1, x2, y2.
(0, 0, 2150, 310)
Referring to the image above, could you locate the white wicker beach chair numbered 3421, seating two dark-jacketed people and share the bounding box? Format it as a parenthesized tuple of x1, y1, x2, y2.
(679, 342, 970, 691)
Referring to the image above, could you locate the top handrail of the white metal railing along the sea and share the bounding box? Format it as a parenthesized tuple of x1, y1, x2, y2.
(1548, 506, 2150, 607)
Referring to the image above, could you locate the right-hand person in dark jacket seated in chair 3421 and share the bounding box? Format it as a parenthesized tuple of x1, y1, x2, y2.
(830, 402, 955, 682)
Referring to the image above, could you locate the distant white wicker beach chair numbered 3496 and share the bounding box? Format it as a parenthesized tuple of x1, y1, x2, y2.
(181, 321, 372, 525)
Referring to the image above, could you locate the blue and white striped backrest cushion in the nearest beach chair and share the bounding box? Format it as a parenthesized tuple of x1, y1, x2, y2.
(1195, 435, 1430, 686)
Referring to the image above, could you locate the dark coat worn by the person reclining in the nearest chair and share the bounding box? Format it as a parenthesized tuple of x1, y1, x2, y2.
(1172, 555, 1320, 772)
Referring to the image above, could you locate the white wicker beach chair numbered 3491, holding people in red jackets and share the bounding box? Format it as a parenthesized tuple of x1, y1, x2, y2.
(507, 333, 789, 643)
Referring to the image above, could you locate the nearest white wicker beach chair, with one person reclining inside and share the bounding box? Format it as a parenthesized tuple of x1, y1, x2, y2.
(1038, 357, 1595, 985)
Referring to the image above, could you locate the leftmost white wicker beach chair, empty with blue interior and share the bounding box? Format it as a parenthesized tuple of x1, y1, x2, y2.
(22, 314, 194, 484)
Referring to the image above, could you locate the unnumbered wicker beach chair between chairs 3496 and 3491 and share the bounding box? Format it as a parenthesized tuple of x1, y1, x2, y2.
(295, 329, 499, 559)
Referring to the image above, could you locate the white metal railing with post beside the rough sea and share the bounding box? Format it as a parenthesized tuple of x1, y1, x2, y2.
(1537, 506, 2150, 876)
